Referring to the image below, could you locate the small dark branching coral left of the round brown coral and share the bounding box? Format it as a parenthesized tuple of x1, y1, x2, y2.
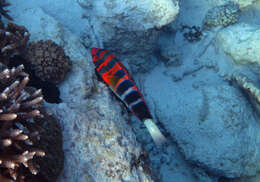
(0, 23, 29, 63)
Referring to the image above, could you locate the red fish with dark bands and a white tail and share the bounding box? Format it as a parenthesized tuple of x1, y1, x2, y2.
(91, 48, 166, 146)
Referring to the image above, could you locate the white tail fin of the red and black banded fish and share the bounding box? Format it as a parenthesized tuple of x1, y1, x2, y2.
(144, 119, 166, 146)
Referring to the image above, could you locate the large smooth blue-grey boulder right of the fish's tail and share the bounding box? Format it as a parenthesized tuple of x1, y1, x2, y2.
(145, 66, 260, 178)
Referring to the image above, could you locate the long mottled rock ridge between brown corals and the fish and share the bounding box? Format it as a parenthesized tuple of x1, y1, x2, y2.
(11, 1, 153, 182)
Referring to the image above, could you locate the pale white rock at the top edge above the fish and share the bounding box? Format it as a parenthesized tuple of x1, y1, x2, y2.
(80, 0, 179, 31)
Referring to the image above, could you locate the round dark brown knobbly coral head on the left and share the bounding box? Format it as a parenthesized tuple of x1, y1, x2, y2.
(27, 40, 71, 84)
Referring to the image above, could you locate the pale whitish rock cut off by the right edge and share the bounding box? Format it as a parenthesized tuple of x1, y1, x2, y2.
(216, 23, 260, 67)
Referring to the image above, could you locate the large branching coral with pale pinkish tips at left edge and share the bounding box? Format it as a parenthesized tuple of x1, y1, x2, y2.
(0, 65, 45, 182)
